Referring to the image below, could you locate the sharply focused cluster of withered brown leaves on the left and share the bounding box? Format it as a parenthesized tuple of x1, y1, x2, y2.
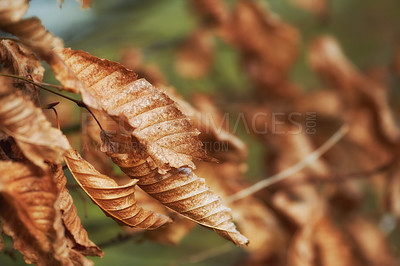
(0, 1, 248, 265)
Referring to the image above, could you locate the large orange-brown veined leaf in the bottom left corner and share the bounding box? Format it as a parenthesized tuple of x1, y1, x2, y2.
(0, 161, 90, 265)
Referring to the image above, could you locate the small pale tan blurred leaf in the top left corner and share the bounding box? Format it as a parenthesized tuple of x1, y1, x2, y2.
(0, 0, 29, 27)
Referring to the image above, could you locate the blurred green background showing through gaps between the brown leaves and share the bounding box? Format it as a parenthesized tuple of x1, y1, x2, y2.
(0, 0, 400, 265)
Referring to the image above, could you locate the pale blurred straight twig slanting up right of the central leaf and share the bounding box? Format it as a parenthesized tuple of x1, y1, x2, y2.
(225, 124, 349, 203)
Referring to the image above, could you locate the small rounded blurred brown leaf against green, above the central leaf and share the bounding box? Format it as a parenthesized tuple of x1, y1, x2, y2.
(175, 28, 214, 79)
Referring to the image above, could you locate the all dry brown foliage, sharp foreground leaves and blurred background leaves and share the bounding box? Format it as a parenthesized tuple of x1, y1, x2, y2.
(0, 0, 400, 266)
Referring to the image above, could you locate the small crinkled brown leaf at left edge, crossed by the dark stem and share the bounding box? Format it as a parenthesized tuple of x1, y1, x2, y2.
(0, 40, 44, 104)
